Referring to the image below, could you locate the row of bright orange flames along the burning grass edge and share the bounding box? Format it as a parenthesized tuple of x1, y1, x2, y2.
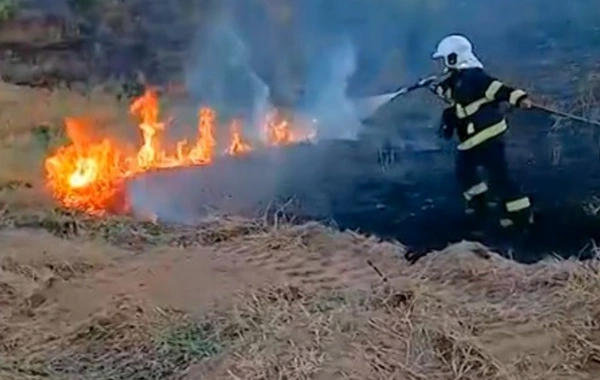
(44, 89, 313, 215)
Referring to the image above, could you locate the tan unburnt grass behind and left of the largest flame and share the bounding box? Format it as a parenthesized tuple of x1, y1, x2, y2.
(0, 81, 191, 203)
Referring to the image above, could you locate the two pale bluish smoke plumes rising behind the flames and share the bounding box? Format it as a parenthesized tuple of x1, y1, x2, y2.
(186, 4, 361, 139)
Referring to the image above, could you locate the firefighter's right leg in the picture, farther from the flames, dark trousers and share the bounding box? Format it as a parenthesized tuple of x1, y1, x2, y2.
(483, 138, 533, 227)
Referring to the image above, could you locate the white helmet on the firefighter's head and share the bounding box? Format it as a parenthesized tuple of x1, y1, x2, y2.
(432, 34, 483, 70)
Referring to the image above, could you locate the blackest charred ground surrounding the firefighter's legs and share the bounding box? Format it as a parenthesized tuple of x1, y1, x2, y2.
(278, 106, 600, 263)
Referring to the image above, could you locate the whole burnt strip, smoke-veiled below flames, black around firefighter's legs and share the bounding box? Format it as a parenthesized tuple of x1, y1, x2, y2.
(129, 111, 600, 263)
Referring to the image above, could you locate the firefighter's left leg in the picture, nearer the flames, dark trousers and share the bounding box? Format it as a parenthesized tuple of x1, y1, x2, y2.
(456, 150, 488, 220)
